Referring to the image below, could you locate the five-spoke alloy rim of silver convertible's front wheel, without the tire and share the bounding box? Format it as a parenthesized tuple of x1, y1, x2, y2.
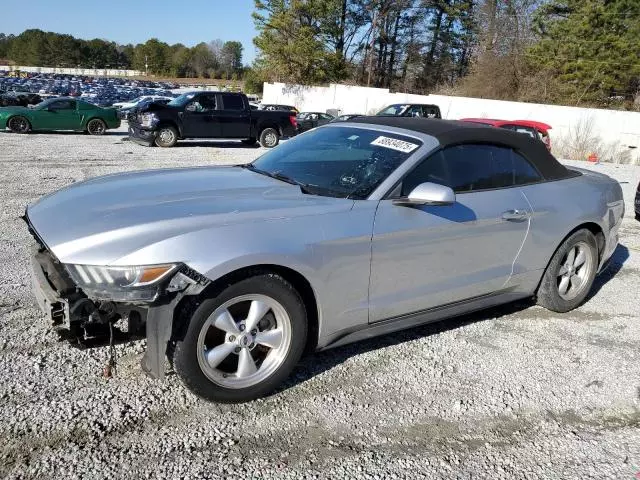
(197, 294, 292, 389)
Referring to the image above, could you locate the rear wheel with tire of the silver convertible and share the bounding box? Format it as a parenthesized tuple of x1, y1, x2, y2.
(537, 230, 599, 313)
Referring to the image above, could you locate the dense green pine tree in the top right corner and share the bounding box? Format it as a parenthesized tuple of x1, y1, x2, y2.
(528, 0, 640, 105)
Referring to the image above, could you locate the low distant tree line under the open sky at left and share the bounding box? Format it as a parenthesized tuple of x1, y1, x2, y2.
(0, 29, 244, 79)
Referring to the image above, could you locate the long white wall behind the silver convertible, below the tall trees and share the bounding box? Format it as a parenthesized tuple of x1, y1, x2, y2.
(262, 83, 640, 163)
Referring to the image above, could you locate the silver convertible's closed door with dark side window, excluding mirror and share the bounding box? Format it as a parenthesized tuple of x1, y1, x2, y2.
(369, 145, 540, 322)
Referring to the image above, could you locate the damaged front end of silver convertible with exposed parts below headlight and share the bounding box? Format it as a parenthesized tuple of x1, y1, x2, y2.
(25, 216, 210, 378)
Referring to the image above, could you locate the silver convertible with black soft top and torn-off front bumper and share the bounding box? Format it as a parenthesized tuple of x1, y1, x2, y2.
(25, 117, 624, 402)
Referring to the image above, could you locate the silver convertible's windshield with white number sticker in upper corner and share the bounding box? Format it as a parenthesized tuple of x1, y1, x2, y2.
(252, 127, 422, 199)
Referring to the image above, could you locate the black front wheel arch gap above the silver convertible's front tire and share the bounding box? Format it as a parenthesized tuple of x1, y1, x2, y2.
(172, 264, 320, 353)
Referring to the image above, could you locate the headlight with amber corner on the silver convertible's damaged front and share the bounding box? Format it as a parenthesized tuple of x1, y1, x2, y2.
(66, 264, 178, 302)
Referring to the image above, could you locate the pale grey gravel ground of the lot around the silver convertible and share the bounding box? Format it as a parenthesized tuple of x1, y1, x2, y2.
(0, 129, 640, 479)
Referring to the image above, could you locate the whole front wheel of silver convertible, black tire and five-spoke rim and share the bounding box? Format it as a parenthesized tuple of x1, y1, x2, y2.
(173, 273, 307, 403)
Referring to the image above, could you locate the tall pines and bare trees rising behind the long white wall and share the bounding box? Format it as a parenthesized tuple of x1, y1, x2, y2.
(252, 0, 640, 108)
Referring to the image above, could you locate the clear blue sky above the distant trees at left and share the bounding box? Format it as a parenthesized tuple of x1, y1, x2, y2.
(0, 0, 256, 63)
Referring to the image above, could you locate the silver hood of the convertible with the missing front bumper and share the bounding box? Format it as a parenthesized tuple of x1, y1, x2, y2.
(27, 167, 353, 265)
